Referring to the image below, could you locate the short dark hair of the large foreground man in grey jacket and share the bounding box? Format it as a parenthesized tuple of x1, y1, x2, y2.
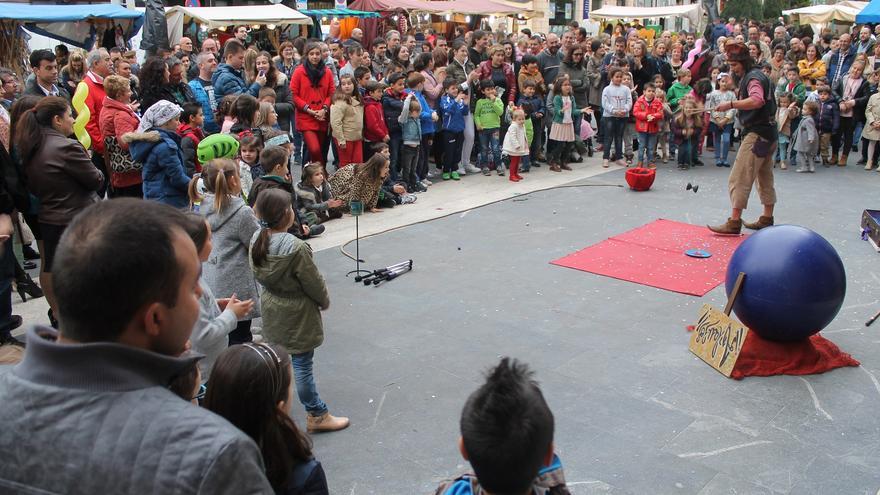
(52, 198, 186, 342)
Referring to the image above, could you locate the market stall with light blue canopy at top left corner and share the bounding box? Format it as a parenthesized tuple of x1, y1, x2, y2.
(0, 3, 144, 77)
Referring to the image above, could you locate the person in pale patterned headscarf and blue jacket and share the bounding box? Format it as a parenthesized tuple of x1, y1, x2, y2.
(129, 100, 190, 208)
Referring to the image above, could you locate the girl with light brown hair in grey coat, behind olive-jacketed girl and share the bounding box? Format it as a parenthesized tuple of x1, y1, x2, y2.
(199, 159, 260, 345)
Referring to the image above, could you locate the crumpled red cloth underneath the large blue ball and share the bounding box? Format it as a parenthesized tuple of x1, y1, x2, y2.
(688, 326, 860, 380)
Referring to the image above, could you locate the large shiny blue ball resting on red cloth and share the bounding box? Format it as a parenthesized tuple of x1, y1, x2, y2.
(725, 225, 846, 341)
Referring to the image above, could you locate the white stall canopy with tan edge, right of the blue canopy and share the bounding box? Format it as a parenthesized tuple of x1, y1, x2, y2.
(165, 4, 312, 45)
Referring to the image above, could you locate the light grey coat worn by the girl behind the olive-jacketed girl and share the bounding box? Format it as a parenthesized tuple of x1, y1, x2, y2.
(199, 193, 260, 320)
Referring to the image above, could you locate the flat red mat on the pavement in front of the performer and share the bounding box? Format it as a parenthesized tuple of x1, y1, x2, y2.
(551, 219, 745, 296)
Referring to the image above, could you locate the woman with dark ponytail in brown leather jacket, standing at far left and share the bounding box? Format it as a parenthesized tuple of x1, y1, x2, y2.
(15, 96, 104, 325)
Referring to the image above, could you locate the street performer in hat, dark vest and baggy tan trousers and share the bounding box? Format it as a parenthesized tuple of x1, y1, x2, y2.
(708, 42, 777, 234)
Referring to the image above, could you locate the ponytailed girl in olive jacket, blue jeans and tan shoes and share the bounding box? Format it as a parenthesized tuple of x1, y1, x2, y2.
(250, 189, 349, 432)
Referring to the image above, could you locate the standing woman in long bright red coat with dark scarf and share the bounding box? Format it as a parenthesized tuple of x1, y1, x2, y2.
(290, 43, 334, 165)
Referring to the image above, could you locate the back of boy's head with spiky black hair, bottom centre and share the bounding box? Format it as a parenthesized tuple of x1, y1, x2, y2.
(460, 357, 553, 494)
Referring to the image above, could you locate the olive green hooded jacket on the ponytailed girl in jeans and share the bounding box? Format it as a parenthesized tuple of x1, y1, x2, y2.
(248, 230, 330, 354)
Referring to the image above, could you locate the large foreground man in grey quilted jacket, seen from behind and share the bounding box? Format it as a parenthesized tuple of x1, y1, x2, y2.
(0, 199, 272, 495)
